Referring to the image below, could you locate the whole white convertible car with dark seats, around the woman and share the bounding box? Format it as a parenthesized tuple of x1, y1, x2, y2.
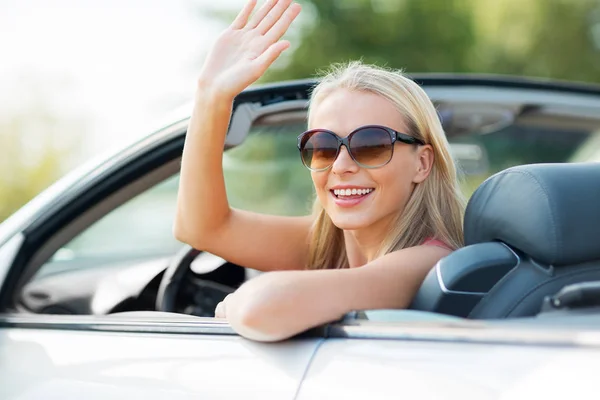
(0, 75, 600, 400)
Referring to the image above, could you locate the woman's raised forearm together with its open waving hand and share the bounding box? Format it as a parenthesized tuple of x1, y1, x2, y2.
(173, 0, 300, 249)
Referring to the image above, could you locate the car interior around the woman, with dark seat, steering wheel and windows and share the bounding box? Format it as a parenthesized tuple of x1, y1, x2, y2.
(11, 83, 600, 330)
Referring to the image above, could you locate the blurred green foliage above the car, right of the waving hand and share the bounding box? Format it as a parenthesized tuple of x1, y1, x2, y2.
(265, 0, 600, 82)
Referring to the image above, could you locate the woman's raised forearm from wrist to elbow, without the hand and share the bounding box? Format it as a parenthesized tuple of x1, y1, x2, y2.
(174, 84, 232, 247)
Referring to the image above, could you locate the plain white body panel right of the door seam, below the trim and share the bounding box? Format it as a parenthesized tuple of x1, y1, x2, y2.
(297, 339, 600, 400)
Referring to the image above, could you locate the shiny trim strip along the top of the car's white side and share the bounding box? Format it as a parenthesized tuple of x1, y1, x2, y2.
(0, 314, 600, 348)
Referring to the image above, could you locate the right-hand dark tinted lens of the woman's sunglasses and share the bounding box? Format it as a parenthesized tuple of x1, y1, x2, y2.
(350, 128, 393, 167)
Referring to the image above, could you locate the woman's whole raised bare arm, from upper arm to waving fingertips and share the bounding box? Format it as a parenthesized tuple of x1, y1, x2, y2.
(173, 0, 312, 288)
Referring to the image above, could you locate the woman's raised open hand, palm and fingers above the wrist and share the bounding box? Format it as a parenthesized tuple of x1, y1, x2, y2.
(199, 0, 301, 100)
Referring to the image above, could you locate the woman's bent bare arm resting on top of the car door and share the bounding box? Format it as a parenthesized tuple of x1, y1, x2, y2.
(215, 246, 450, 341)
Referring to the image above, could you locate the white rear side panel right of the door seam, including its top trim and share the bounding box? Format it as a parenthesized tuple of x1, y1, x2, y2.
(297, 310, 600, 400)
